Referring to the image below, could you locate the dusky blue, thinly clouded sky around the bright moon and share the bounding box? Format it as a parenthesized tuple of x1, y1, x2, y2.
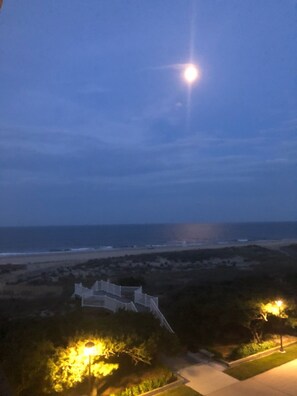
(0, 0, 297, 225)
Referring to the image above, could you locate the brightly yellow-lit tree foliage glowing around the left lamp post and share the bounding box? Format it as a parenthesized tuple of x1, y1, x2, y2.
(45, 334, 155, 393)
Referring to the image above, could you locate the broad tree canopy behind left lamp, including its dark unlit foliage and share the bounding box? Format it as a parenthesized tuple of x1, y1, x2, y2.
(0, 311, 175, 396)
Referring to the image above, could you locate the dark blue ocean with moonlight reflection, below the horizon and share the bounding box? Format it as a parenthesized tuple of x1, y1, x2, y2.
(0, 222, 297, 256)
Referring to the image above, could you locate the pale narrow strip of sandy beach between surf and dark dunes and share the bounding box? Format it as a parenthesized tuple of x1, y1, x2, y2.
(0, 239, 297, 271)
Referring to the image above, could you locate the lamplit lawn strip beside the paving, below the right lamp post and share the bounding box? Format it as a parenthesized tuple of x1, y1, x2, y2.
(225, 343, 297, 381)
